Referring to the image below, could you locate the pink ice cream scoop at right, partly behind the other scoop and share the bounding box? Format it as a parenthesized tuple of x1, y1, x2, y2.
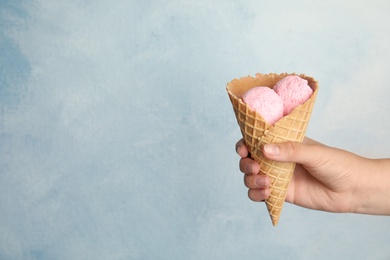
(274, 76, 313, 116)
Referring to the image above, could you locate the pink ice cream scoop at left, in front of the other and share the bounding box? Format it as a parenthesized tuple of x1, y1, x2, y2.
(242, 87, 283, 125)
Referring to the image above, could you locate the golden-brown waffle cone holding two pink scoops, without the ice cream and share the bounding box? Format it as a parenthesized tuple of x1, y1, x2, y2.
(226, 73, 318, 226)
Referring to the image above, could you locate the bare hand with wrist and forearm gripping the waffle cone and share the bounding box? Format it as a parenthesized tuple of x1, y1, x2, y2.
(236, 138, 390, 215)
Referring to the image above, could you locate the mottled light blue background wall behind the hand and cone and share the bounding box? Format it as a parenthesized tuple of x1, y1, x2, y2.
(0, 0, 390, 259)
